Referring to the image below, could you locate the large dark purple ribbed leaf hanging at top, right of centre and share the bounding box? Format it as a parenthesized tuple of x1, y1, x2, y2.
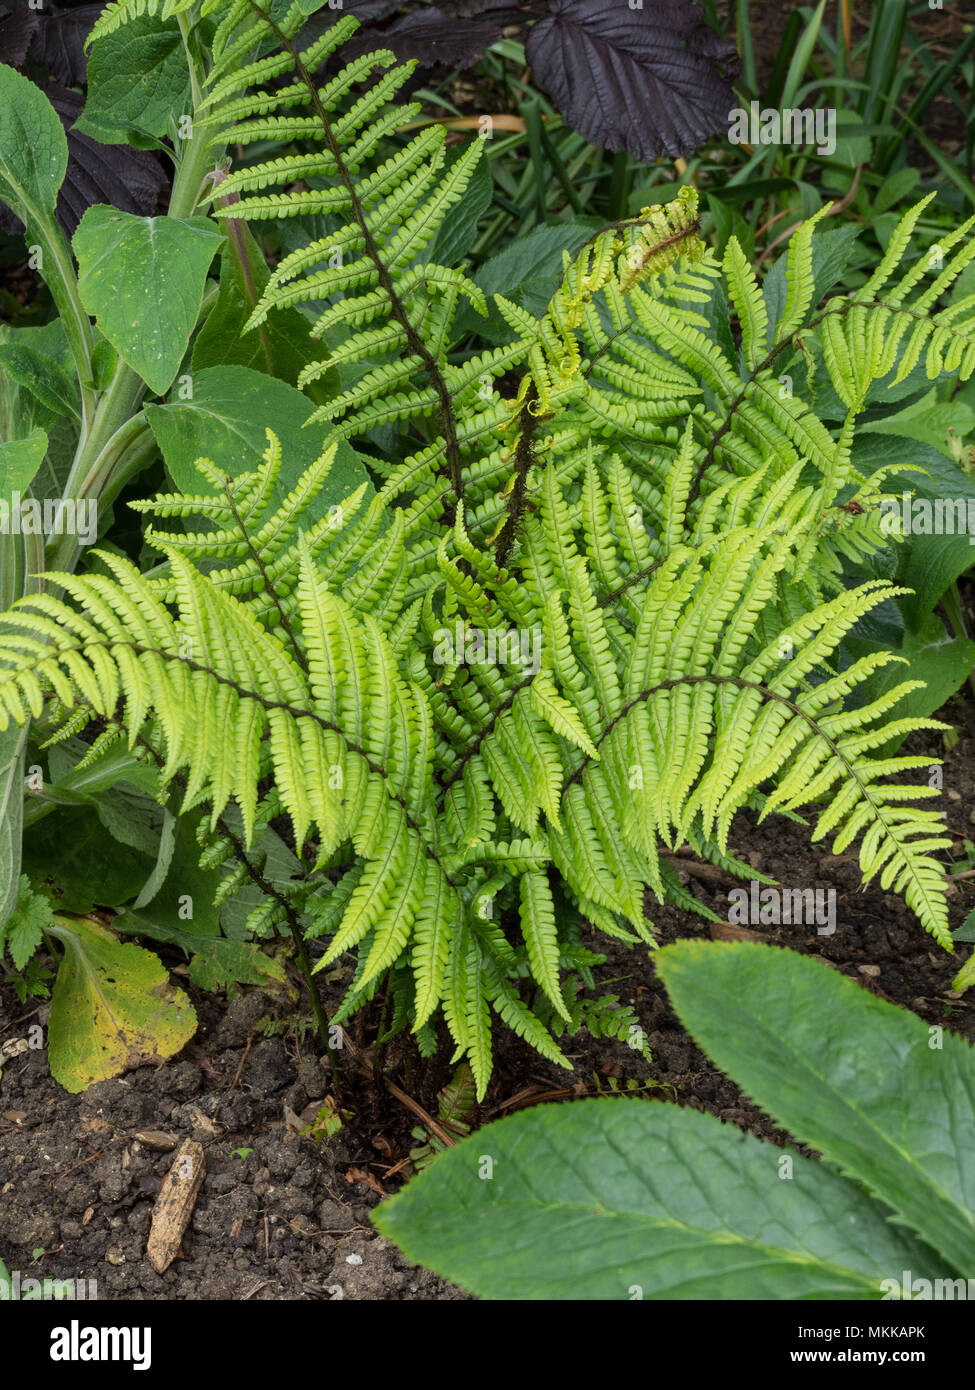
(526, 0, 740, 161)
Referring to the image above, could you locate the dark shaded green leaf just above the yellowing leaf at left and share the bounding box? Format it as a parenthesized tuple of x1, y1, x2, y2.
(24, 806, 153, 913)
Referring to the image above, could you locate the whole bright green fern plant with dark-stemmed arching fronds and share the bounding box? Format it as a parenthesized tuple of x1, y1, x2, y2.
(0, 0, 975, 1095)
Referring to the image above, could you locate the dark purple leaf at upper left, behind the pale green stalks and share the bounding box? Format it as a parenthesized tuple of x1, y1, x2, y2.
(0, 83, 168, 236)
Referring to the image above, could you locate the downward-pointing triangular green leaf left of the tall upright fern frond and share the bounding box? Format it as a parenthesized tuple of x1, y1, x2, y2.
(72, 204, 224, 395)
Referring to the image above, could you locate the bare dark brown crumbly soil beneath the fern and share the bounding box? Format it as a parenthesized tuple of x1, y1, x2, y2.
(0, 696, 975, 1300)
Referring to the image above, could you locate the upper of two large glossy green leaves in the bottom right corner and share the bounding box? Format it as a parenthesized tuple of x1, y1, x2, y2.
(655, 941, 975, 1277)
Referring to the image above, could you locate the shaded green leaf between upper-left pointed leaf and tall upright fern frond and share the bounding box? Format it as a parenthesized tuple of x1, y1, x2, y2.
(193, 220, 338, 397)
